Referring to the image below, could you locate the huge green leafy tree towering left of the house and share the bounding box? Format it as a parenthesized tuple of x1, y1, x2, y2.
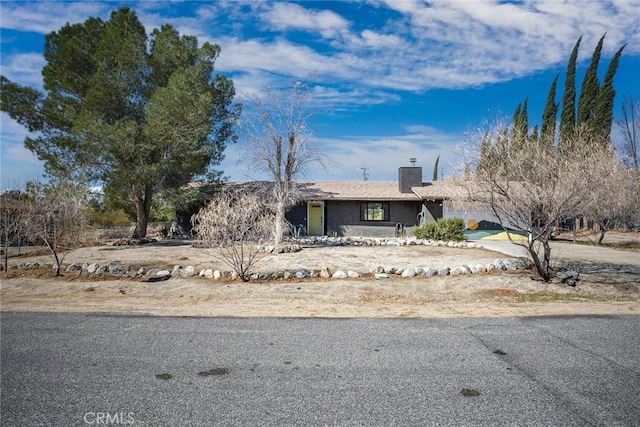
(0, 7, 240, 236)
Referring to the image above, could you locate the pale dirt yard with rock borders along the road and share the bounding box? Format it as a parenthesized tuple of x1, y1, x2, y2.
(0, 233, 640, 318)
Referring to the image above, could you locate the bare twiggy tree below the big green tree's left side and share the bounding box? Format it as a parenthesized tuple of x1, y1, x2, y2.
(27, 183, 92, 276)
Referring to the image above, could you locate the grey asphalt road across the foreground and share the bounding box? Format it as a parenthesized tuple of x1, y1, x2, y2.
(0, 312, 640, 426)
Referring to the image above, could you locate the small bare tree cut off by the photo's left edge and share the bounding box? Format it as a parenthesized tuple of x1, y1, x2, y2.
(0, 190, 31, 271)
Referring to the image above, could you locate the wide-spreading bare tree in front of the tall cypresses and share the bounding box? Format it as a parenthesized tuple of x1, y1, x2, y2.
(457, 122, 614, 281)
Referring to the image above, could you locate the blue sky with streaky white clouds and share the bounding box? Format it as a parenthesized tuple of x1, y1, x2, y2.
(0, 0, 640, 189)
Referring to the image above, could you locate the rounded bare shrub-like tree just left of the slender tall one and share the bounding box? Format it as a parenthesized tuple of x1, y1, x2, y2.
(192, 189, 274, 282)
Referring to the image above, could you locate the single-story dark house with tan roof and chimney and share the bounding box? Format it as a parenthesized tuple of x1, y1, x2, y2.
(286, 166, 447, 237)
